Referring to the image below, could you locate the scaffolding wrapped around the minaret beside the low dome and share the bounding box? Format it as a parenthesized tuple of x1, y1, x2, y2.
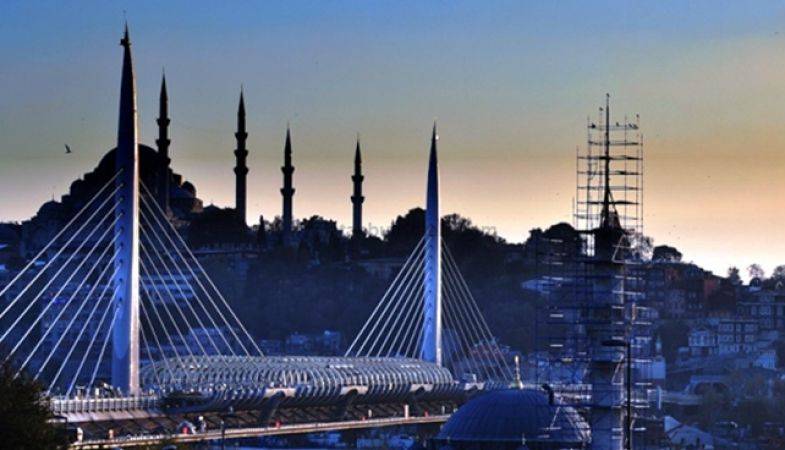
(538, 96, 651, 449)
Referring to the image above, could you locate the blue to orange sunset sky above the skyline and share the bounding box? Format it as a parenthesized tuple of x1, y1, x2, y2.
(0, 0, 785, 274)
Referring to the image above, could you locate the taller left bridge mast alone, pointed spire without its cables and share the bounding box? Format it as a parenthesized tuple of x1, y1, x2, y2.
(112, 24, 139, 394)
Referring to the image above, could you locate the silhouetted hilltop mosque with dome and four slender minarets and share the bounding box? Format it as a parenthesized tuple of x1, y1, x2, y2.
(18, 59, 365, 257)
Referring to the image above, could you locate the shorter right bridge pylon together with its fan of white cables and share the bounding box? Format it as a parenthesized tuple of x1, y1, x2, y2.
(346, 124, 513, 383)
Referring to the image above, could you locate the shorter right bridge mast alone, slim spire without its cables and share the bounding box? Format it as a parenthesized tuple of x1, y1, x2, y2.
(421, 123, 442, 365)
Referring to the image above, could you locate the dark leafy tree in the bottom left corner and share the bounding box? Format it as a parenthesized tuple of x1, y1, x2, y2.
(0, 363, 68, 450)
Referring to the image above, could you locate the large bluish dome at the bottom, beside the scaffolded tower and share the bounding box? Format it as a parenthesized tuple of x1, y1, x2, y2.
(434, 389, 590, 450)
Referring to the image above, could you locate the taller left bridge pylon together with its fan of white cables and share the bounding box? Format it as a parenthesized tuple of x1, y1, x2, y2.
(0, 27, 262, 395)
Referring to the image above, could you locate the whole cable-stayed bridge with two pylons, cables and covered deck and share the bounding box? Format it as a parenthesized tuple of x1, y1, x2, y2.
(0, 30, 513, 448)
